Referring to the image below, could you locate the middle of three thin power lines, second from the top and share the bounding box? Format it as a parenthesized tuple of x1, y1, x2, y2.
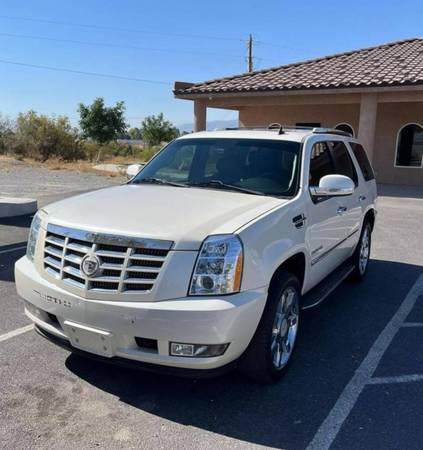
(0, 32, 247, 58)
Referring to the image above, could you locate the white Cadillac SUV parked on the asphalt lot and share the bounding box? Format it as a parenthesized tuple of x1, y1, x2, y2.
(15, 125, 377, 382)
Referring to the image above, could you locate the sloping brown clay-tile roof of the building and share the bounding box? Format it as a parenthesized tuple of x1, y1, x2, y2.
(174, 38, 423, 96)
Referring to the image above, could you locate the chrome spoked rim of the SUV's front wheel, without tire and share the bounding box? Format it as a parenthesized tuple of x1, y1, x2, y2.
(270, 287, 299, 369)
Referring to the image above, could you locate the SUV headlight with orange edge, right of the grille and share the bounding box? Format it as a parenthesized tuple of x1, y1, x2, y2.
(189, 235, 244, 295)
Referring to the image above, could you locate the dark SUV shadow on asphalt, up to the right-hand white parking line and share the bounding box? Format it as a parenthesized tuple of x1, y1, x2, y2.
(66, 260, 423, 449)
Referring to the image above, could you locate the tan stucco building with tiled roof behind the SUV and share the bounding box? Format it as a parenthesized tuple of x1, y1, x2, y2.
(174, 38, 423, 185)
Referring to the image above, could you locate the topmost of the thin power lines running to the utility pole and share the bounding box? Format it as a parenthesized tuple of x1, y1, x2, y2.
(0, 15, 244, 42)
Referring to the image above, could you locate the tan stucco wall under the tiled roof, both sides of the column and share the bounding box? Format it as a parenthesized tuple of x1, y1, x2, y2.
(239, 102, 423, 185)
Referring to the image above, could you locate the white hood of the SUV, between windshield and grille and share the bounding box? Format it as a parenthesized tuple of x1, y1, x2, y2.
(43, 184, 286, 250)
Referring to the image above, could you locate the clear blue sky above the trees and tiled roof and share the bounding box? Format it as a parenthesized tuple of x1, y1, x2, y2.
(0, 0, 423, 126)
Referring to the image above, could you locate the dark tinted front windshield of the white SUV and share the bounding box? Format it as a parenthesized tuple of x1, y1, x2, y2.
(132, 138, 300, 197)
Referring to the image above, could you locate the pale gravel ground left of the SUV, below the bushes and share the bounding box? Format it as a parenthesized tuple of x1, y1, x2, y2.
(0, 160, 125, 201)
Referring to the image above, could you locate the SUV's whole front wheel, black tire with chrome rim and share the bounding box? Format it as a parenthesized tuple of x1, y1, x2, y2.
(239, 272, 300, 383)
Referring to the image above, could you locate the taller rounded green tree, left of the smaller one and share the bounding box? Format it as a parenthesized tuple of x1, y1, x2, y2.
(78, 97, 127, 145)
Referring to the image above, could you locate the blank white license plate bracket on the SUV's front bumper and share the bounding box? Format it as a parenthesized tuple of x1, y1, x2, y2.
(64, 320, 114, 358)
